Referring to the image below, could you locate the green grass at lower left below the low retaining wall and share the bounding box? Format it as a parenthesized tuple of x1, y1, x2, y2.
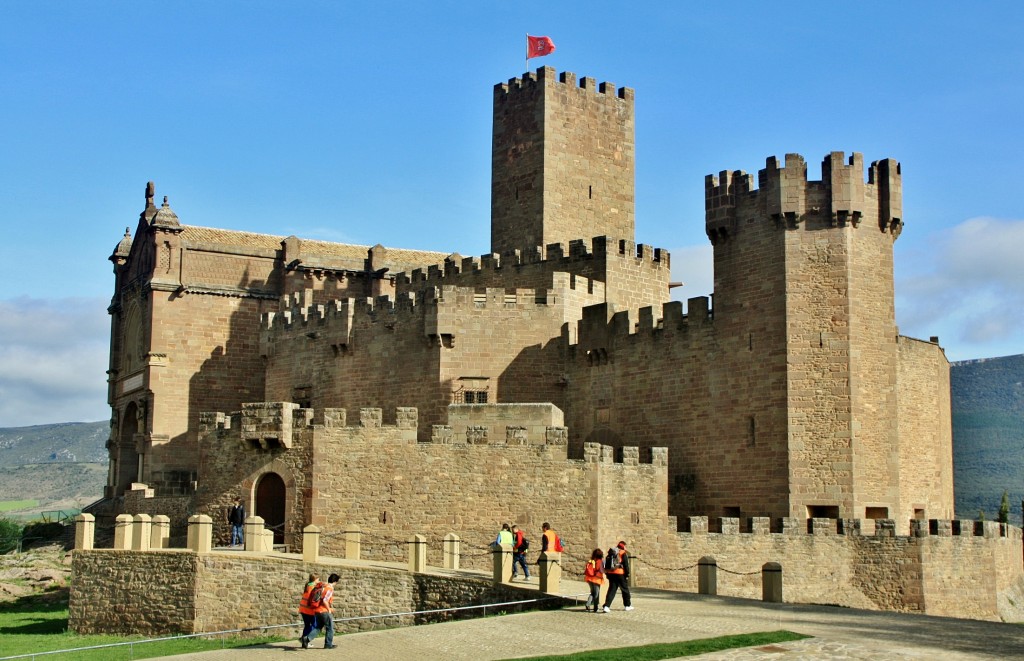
(0, 594, 286, 661)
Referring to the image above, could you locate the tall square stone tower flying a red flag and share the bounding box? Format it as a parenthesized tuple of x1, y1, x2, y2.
(490, 67, 636, 254)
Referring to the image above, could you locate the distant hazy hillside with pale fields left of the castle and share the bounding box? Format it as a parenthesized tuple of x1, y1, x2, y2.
(0, 421, 111, 518)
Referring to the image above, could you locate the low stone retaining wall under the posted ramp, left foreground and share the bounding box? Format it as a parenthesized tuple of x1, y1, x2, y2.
(69, 549, 534, 635)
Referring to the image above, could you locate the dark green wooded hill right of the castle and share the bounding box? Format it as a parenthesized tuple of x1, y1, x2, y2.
(949, 355, 1024, 525)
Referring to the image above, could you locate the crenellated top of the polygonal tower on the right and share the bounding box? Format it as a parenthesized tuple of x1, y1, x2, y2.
(705, 151, 903, 244)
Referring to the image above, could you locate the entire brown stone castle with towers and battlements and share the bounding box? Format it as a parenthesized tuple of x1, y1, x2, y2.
(92, 68, 995, 622)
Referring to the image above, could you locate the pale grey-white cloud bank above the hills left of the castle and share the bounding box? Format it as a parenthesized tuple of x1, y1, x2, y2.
(0, 298, 110, 427)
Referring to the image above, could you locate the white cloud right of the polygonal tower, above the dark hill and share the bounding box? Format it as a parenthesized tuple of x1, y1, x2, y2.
(896, 218, 1024, 360)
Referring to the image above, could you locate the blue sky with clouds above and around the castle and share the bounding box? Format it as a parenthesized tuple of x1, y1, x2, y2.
(0, 0, 1024, 427)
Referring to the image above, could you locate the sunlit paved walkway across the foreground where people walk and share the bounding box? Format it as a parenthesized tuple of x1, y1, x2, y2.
(149, 581, 1024, 661)
